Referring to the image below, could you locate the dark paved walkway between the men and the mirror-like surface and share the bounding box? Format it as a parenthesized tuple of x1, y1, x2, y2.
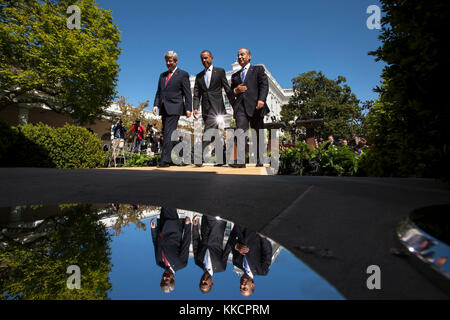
(0, 168, 450, 299)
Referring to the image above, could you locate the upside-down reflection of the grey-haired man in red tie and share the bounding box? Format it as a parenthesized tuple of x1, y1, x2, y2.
(150, 207, 191, 293)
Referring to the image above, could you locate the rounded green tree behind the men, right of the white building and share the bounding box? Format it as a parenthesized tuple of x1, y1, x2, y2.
(281, 71, 364, 139)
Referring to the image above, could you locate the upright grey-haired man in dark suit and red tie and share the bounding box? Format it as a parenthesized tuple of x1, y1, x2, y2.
(153, 51, 192, 167)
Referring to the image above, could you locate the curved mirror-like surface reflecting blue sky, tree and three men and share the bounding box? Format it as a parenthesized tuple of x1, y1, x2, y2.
(0, 204, 343, 300)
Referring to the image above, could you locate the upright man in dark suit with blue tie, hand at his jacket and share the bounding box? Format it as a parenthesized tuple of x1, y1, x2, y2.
(231, 48, 270, 168)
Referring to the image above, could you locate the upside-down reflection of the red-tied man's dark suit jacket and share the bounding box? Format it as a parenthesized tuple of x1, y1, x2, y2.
(152, 210, 191, 271)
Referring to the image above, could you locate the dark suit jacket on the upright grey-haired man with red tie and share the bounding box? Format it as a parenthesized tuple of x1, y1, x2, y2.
(153, 68, 192, 115)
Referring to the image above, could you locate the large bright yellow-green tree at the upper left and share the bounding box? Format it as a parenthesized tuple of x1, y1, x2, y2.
(0, 0, 120, 124)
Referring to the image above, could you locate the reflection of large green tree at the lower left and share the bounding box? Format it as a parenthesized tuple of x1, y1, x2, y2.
(0, 205, 112, 299)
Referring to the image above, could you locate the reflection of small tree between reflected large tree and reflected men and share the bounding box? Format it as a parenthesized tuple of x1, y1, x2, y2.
(112, 204, 159, 235)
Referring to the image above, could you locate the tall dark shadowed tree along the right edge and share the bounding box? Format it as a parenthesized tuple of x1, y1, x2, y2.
(366, 0, 450, 179)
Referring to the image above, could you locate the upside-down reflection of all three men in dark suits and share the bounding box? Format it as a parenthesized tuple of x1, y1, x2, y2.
(151, 207, 272, 296)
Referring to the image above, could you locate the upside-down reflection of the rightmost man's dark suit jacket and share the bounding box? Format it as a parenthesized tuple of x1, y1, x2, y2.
(228, 225, 272, 275)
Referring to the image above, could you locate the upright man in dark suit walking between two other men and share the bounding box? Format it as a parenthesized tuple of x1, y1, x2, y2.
(193, 50, 233, 166)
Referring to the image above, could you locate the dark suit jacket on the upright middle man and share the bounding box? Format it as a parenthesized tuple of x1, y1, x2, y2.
(193, 66, 233, 116)
